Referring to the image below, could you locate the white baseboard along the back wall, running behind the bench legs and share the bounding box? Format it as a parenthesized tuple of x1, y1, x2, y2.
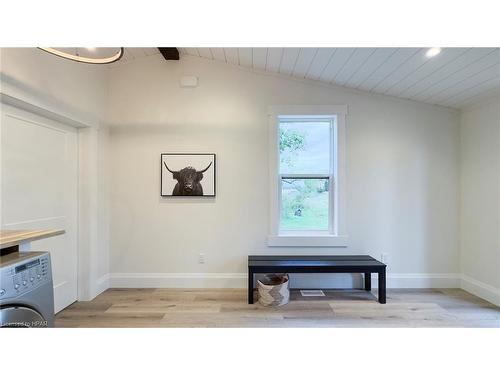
(108, 273, 460, 289)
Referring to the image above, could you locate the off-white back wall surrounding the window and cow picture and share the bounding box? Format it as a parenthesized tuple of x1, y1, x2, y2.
(106, 56, 459, 286)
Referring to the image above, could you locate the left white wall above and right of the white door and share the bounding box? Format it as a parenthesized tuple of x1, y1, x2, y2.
(0, 48, 109, 299)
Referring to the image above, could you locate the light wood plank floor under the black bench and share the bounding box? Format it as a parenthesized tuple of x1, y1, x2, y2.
(55, 289, 500, 328)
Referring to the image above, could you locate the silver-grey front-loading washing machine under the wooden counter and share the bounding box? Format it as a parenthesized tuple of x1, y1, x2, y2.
(0, 252, 54, 328)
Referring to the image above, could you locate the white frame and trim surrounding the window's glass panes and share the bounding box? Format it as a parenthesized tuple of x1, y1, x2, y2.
(267, 105, 348, 247)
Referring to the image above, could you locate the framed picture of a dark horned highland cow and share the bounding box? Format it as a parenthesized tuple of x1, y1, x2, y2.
(161, 154, 215, 197)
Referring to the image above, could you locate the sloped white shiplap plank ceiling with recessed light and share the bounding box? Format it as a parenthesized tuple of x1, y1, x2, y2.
(119, 48, 500, 108)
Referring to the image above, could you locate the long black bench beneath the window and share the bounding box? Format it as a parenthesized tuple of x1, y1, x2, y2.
(248, 255, 387, 304)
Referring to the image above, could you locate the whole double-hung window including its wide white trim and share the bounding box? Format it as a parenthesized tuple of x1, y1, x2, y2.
(268, 106, 346, 246)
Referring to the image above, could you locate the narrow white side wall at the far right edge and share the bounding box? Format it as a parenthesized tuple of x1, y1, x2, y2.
(460, 99, 500, 305)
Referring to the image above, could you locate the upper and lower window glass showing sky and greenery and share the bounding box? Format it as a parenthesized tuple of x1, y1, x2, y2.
(278, 117, 335, 232)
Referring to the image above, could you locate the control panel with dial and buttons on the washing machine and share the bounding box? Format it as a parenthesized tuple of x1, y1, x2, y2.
(0, 253, 52, 300)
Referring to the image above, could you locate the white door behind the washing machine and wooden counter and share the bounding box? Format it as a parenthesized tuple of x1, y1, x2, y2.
(1, 104, 78, 312)
